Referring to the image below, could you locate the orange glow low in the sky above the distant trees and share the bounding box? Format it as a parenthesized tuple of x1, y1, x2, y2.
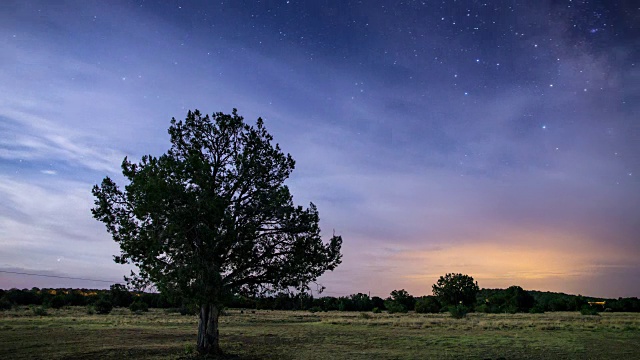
(380, 229, 637, 293)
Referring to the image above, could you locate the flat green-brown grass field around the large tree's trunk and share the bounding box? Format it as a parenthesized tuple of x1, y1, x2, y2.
(0, 307, 640, 360)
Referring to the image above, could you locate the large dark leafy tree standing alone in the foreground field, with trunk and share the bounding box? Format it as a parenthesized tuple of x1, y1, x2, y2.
(92, 109, 342, 353)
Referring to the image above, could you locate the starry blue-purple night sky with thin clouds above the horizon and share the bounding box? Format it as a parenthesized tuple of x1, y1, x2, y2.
(0, 0, 640, 297)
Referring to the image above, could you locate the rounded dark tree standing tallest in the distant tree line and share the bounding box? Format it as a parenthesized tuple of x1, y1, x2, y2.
(433, 273, 480, 306)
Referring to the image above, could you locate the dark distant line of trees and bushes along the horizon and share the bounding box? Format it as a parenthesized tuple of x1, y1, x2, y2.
(0, 274, 640, 315)
